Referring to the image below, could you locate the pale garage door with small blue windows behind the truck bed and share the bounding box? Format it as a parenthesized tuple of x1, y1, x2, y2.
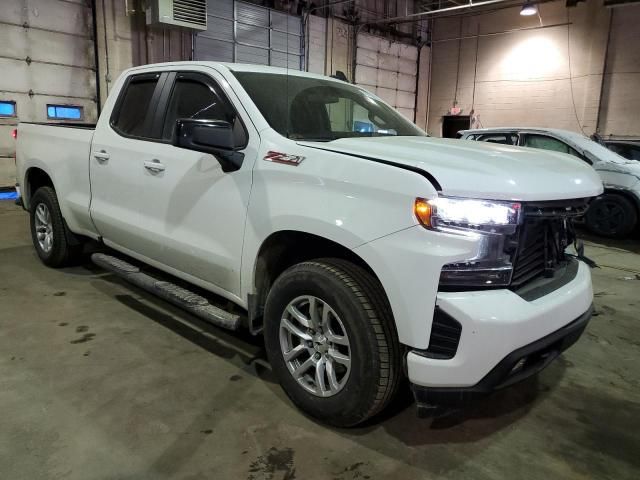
(0, 0, 97, 187)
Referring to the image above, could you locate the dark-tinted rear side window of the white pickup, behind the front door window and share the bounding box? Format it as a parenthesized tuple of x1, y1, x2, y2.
(111, 73, 160, 138)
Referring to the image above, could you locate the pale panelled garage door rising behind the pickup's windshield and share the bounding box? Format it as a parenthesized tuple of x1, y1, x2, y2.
(356, 33, 418, 121)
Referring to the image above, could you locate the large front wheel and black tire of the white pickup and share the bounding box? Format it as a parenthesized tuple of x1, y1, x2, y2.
(264, 259, 402, 427)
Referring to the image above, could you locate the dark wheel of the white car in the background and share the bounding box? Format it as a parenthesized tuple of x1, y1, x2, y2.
(585, 193, 638, 238)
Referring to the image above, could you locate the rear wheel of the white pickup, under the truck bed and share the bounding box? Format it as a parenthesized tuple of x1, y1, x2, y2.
(29, 187, 82, 268)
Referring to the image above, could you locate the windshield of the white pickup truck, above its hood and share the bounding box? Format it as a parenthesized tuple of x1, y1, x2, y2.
(233, 72, 425, 142)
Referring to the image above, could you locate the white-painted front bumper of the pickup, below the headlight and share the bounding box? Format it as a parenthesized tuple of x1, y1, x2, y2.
(407, 262, 593, 389)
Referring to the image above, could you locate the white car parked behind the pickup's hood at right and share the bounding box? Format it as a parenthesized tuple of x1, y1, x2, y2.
(460, 127, 640, 237)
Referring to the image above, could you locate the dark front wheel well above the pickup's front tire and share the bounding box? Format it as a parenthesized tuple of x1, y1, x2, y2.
(249, 230, 379, 333)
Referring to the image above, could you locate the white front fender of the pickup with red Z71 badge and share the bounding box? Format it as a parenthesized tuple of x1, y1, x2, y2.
(241, 142, 437, 299)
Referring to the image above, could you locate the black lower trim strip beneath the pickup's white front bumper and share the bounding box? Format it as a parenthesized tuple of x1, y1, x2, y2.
(411, 306, 593, 408)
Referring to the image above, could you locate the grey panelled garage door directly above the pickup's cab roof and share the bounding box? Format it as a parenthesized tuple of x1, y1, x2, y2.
(194, 0, 304, 70)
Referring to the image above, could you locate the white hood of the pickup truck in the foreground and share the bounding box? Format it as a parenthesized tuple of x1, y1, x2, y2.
(298, 137, 602, 201)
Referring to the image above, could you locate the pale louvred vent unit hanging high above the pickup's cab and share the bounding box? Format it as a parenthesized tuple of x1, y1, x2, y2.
(146, 0, 207, 30)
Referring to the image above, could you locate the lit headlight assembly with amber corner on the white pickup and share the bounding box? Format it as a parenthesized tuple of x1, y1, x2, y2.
(414, 197, 521, 288)
